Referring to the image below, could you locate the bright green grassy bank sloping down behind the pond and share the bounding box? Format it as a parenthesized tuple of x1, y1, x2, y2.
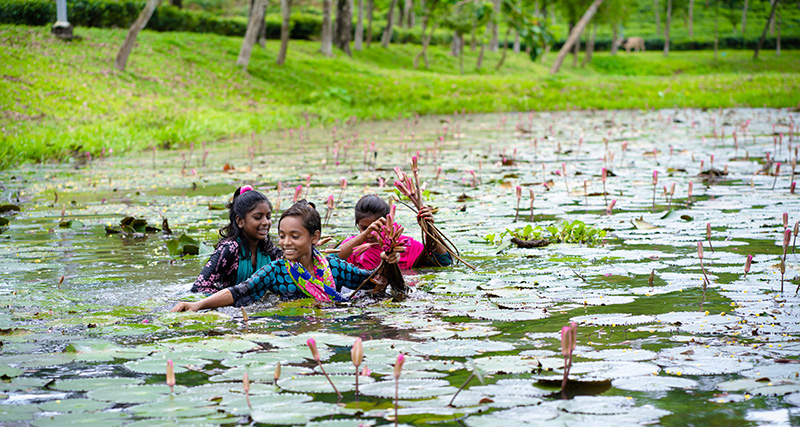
(0, 26, 800, 167)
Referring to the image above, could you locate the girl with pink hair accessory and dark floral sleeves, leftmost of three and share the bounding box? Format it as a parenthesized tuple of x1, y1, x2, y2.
(192, 185, 283, 295)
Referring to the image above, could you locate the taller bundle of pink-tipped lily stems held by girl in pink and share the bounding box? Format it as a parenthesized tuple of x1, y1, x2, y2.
(394, 156, 475, 270)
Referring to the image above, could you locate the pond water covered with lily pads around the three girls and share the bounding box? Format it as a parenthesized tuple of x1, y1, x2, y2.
(0, 109, 800, 427)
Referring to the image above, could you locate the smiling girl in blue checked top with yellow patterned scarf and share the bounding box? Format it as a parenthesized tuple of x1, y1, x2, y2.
(172, 200, 400, 311)
